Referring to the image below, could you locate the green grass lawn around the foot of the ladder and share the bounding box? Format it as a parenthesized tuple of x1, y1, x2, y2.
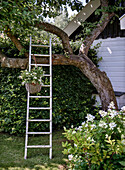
(0, 131, 66, 170)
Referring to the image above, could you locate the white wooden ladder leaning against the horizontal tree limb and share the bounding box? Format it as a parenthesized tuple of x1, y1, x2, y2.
(24, 37, 52, 159)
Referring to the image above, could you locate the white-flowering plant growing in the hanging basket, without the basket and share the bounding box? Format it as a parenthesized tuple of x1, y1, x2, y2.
(19, 67, 44, 85)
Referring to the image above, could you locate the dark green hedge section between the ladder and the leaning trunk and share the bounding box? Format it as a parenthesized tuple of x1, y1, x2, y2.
(53, 66, 94, 127)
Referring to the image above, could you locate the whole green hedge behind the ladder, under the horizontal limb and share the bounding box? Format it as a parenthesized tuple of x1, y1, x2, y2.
(0, 66, 95, 134)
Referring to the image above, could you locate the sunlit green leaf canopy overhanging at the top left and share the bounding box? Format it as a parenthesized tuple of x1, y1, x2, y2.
(0, 0, 82, 36)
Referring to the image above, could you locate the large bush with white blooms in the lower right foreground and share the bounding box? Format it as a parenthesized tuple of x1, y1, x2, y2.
(63, 102, 125, 170)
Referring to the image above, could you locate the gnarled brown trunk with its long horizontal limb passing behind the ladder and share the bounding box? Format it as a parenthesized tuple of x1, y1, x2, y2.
(0, 53, 117, 110)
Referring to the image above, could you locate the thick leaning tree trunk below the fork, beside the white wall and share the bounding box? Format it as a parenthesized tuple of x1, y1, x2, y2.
(71, 55, 118, 110)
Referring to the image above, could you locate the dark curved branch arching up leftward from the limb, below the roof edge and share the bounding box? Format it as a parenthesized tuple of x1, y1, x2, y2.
(36, 22, 73, 55)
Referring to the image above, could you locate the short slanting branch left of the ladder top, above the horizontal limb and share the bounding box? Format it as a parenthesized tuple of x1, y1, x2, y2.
(4, 29, 29, 58)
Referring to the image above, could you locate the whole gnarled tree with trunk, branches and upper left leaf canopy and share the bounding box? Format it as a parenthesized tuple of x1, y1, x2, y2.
(0, 0, 123, 110)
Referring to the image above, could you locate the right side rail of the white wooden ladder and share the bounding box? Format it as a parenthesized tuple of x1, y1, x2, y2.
(49, 38, 52, 159)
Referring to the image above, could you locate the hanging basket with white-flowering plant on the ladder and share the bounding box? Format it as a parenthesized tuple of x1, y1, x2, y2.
(19, 67, 45, 94)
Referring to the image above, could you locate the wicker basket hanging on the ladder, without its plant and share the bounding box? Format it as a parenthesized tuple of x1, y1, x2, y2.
(25, 83, 42, 94)
